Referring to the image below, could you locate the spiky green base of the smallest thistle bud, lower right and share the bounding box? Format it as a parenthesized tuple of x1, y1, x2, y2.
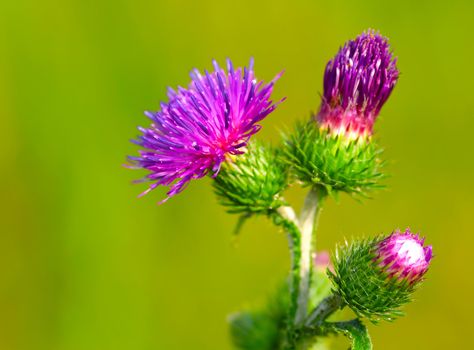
(328, 236, 417, 323)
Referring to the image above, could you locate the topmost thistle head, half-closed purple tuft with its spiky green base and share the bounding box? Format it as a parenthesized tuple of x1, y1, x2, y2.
(286, 31, 398, 195)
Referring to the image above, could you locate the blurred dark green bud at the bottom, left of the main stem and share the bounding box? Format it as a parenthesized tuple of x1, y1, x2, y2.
(229, 283, 289, 350)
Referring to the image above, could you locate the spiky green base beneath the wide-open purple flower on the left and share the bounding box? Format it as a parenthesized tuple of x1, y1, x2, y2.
(214, 142, 288, 214)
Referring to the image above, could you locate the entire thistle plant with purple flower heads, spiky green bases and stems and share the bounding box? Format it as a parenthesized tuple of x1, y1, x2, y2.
(129, 30, 432, 350)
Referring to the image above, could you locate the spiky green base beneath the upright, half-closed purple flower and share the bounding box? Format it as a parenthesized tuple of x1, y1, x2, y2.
(285, 121, 383, 196)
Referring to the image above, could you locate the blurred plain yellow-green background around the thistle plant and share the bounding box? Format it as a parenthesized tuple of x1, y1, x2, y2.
(0, 0, 474, 350)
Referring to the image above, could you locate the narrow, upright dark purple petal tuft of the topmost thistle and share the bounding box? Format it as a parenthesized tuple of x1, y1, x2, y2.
(317, 30, 399, 139)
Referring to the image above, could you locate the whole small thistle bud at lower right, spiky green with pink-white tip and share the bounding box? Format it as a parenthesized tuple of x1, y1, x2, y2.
(328, 233, 431, 323)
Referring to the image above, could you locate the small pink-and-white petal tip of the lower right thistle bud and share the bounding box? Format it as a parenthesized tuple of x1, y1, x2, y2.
(375, 229, 433, 283)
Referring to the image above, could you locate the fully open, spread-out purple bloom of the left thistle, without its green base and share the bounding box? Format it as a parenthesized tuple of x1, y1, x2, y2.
(129, 59, 283, 203)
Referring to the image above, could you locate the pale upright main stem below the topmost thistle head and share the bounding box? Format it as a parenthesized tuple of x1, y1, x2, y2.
(294, 188, 324, 325)
